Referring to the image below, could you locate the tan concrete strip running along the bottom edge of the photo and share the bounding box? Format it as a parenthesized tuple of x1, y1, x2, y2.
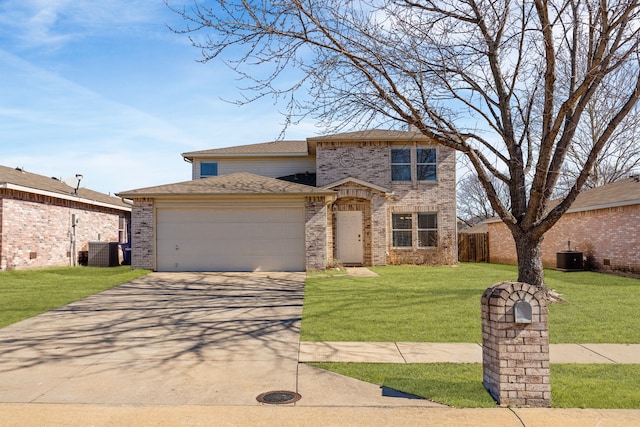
(0, 403, 640, 427)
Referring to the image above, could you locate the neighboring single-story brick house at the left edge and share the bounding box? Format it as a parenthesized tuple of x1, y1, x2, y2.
(0, 166, 131, 270)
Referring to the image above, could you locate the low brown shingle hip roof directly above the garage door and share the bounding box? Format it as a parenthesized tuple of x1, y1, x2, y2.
(118, 172, 335, 198)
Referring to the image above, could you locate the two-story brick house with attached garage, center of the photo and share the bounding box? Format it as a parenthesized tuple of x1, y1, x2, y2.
(119, 130, 457, 271)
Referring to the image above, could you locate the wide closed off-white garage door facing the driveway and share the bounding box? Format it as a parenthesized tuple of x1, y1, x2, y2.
(156, 207, 305, 271)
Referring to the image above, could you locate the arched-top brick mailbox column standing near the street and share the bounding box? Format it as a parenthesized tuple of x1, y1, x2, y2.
(481, 282, 551, 407)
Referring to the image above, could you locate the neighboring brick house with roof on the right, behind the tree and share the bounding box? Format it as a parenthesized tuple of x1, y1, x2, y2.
(488, 177, 640, 273)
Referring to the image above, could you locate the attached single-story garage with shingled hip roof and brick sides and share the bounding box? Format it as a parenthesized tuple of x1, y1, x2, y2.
(118, 173, 335, 271)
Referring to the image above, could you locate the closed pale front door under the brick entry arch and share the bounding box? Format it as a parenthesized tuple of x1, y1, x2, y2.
(336, 211, 364, 264)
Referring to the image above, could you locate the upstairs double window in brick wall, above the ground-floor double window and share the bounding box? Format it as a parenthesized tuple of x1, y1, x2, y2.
(391, 147, 437, 182)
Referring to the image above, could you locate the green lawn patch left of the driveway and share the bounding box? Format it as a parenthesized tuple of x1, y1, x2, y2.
(0, 266, 149, 327)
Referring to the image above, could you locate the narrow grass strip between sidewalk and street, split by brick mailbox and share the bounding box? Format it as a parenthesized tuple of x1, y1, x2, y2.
(312, 363, 640, 409)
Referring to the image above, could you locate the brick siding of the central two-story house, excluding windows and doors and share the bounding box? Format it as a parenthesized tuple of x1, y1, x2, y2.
(132, 136, 458, 270)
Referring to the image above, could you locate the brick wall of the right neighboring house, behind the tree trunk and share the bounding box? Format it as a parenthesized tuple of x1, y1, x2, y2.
(489, 205, 640, 273)
